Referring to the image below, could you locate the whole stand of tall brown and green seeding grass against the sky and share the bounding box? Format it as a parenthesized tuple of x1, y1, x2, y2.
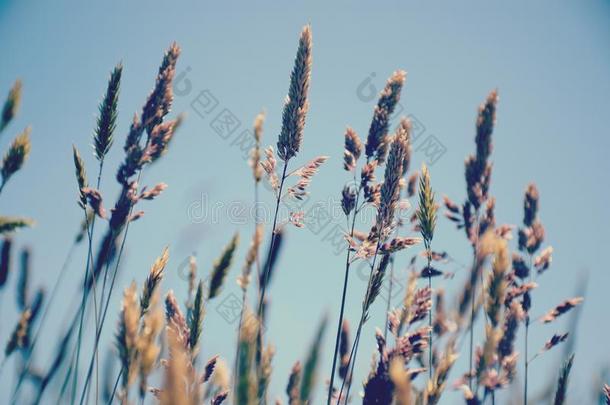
(0, 22, 610, 405)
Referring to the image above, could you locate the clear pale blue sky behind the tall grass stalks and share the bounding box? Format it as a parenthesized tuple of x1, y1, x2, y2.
(0, 0, 610, 403)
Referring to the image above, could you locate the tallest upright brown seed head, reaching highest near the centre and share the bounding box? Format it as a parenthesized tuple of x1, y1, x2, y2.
(277, 25, 312, 161)
